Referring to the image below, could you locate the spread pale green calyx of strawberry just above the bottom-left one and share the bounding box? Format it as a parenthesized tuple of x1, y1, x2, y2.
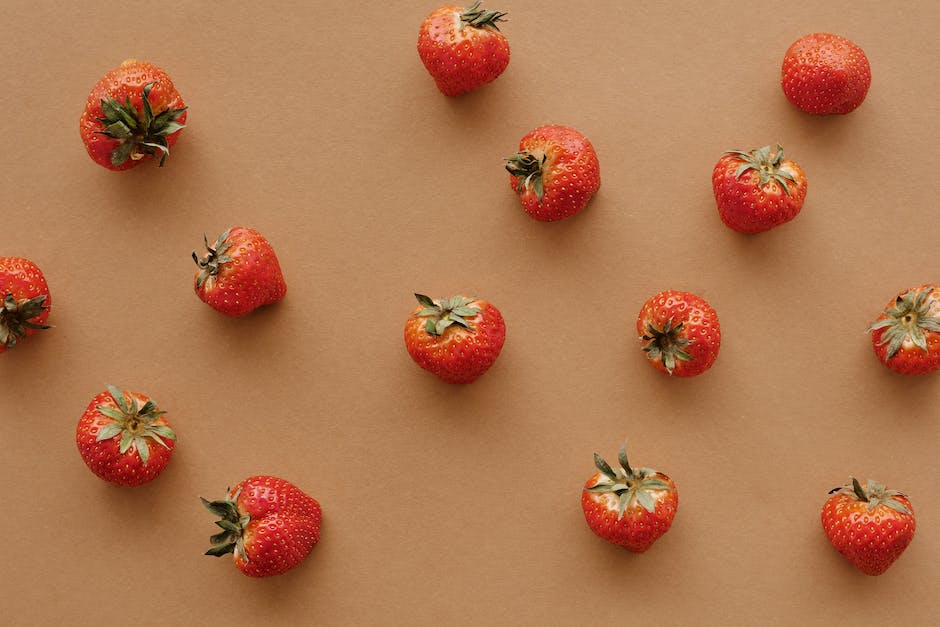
(95, 385, 176, 466)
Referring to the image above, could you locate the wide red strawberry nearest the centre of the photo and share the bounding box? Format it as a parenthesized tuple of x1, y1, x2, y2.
(405, 294, 506, 383)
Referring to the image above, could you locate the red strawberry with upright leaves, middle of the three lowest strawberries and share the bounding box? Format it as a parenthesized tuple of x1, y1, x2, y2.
(581, 444, 679, 553)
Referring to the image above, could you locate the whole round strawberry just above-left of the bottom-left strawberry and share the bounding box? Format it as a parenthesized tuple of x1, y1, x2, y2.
(75, 385, 176, 486)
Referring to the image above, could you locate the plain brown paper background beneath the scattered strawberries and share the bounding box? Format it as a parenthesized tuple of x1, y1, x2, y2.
(0, 0, 940, 625)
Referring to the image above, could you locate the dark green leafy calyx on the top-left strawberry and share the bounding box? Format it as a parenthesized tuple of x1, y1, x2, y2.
(98, 83, 186, 167)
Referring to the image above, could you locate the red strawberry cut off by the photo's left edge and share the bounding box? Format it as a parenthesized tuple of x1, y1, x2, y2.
(0, 257, 52, 353)
